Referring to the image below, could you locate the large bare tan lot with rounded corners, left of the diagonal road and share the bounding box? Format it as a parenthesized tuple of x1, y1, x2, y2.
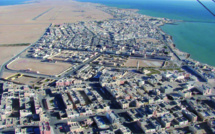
(8, 58, 71, 75)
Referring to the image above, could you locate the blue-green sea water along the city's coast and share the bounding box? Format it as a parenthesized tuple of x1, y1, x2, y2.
(78, 0, 215, 66)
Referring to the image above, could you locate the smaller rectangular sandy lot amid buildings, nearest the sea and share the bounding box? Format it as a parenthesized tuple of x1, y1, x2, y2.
(125, 58, 163, 67)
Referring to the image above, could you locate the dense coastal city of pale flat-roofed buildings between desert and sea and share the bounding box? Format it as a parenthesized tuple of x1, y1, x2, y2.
(0, 5, 215, 134)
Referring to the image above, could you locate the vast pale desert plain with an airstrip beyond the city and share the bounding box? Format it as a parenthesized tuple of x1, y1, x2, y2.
(0, 0, 111, 44)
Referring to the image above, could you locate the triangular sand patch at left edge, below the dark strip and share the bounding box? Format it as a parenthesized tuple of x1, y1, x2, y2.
(0, 46, 27, 66)
